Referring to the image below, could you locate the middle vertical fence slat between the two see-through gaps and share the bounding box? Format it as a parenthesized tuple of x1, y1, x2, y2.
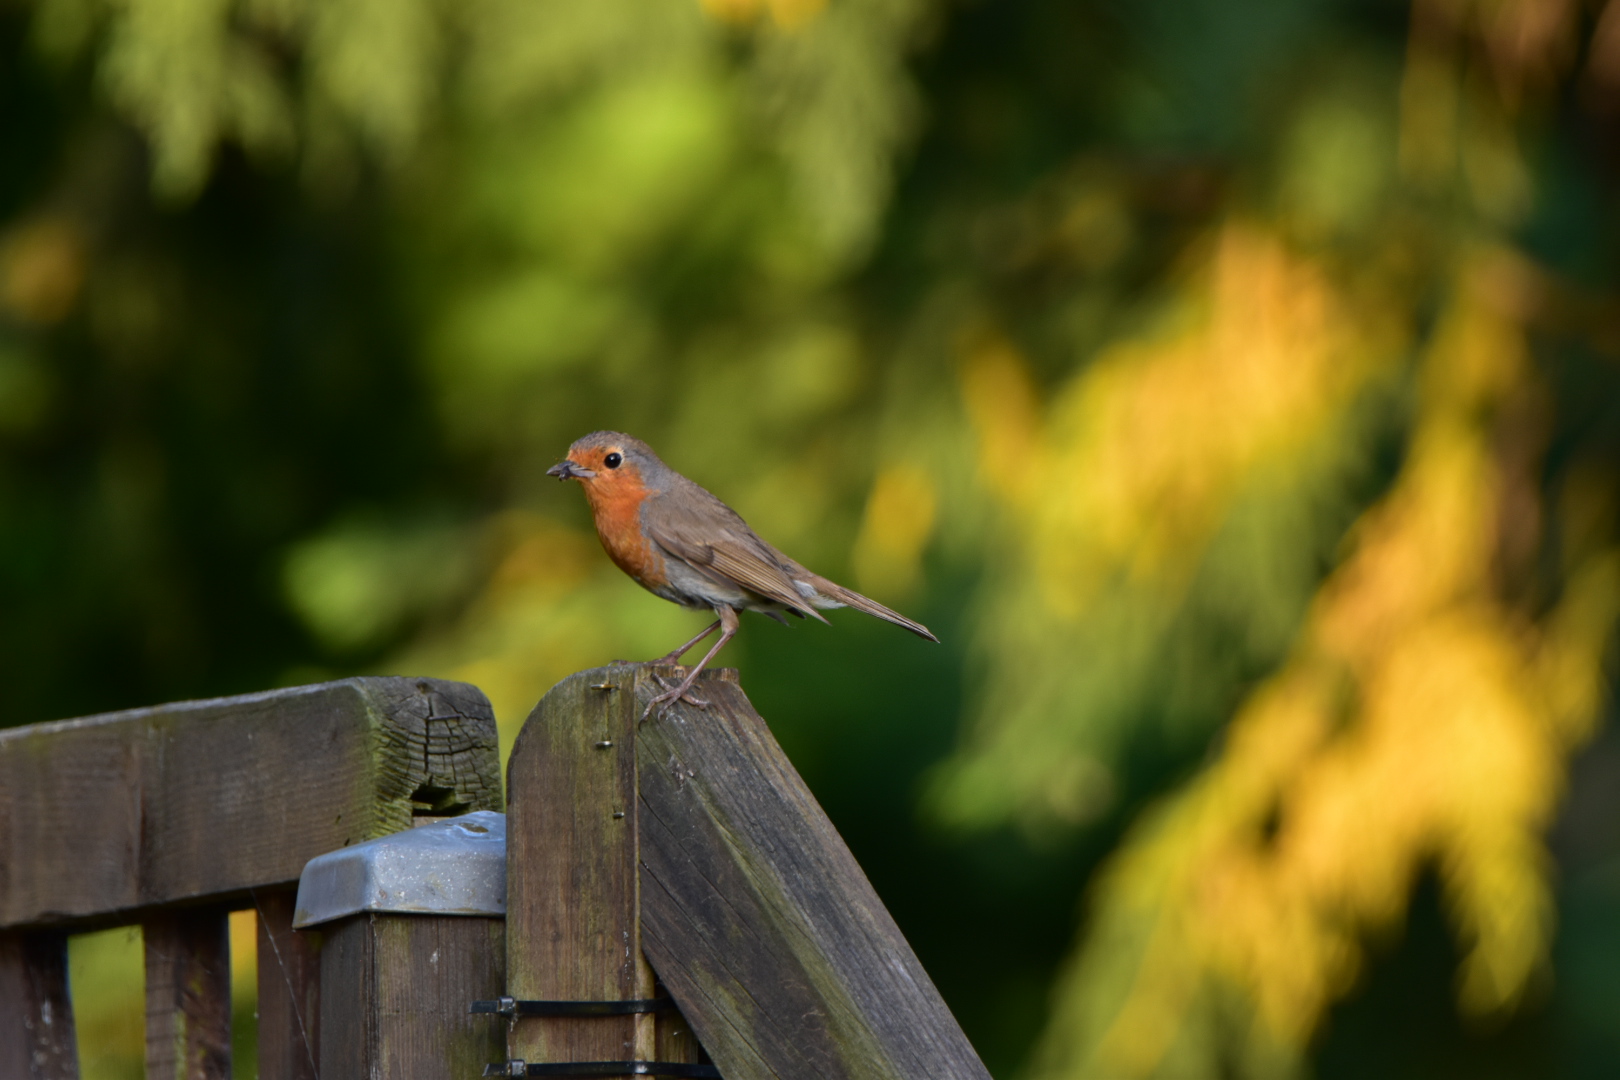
(141, 907, 230, 1080)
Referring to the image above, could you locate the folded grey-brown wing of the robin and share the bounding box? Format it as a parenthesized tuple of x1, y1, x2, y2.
(642, 481, 826, 622)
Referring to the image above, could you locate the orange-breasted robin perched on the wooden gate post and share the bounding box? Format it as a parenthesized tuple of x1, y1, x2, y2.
(546, 431, 940, 721)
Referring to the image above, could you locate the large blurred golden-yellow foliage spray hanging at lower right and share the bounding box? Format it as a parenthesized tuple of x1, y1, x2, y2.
(1042, 253, 1620, 1078)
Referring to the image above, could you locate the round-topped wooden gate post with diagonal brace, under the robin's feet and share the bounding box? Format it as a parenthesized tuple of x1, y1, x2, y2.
(505, 664, 990, 1080)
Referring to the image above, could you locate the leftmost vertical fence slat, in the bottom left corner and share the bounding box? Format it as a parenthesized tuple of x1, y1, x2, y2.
(0, 929, 79, 1080)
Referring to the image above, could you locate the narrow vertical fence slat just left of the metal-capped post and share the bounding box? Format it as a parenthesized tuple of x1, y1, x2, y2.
(254, 889, 321, 1080)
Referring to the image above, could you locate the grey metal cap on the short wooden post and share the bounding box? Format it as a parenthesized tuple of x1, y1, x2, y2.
(293, 810, 505, 929)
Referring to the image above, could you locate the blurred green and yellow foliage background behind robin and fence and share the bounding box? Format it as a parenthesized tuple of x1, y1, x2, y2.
(9, 0, 1620, 1080)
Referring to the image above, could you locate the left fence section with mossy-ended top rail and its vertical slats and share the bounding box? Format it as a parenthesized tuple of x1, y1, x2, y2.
(0, 678, 502, 1080)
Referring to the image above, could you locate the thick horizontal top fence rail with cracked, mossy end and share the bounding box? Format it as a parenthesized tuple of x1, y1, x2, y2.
(0, 678, 501, 928)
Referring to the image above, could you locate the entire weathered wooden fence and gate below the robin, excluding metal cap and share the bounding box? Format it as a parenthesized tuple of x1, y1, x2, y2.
(0, 664, 988, 1080)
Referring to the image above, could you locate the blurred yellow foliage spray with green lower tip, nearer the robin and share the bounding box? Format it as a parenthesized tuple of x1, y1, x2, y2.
(932, 222, 1405, 829)
